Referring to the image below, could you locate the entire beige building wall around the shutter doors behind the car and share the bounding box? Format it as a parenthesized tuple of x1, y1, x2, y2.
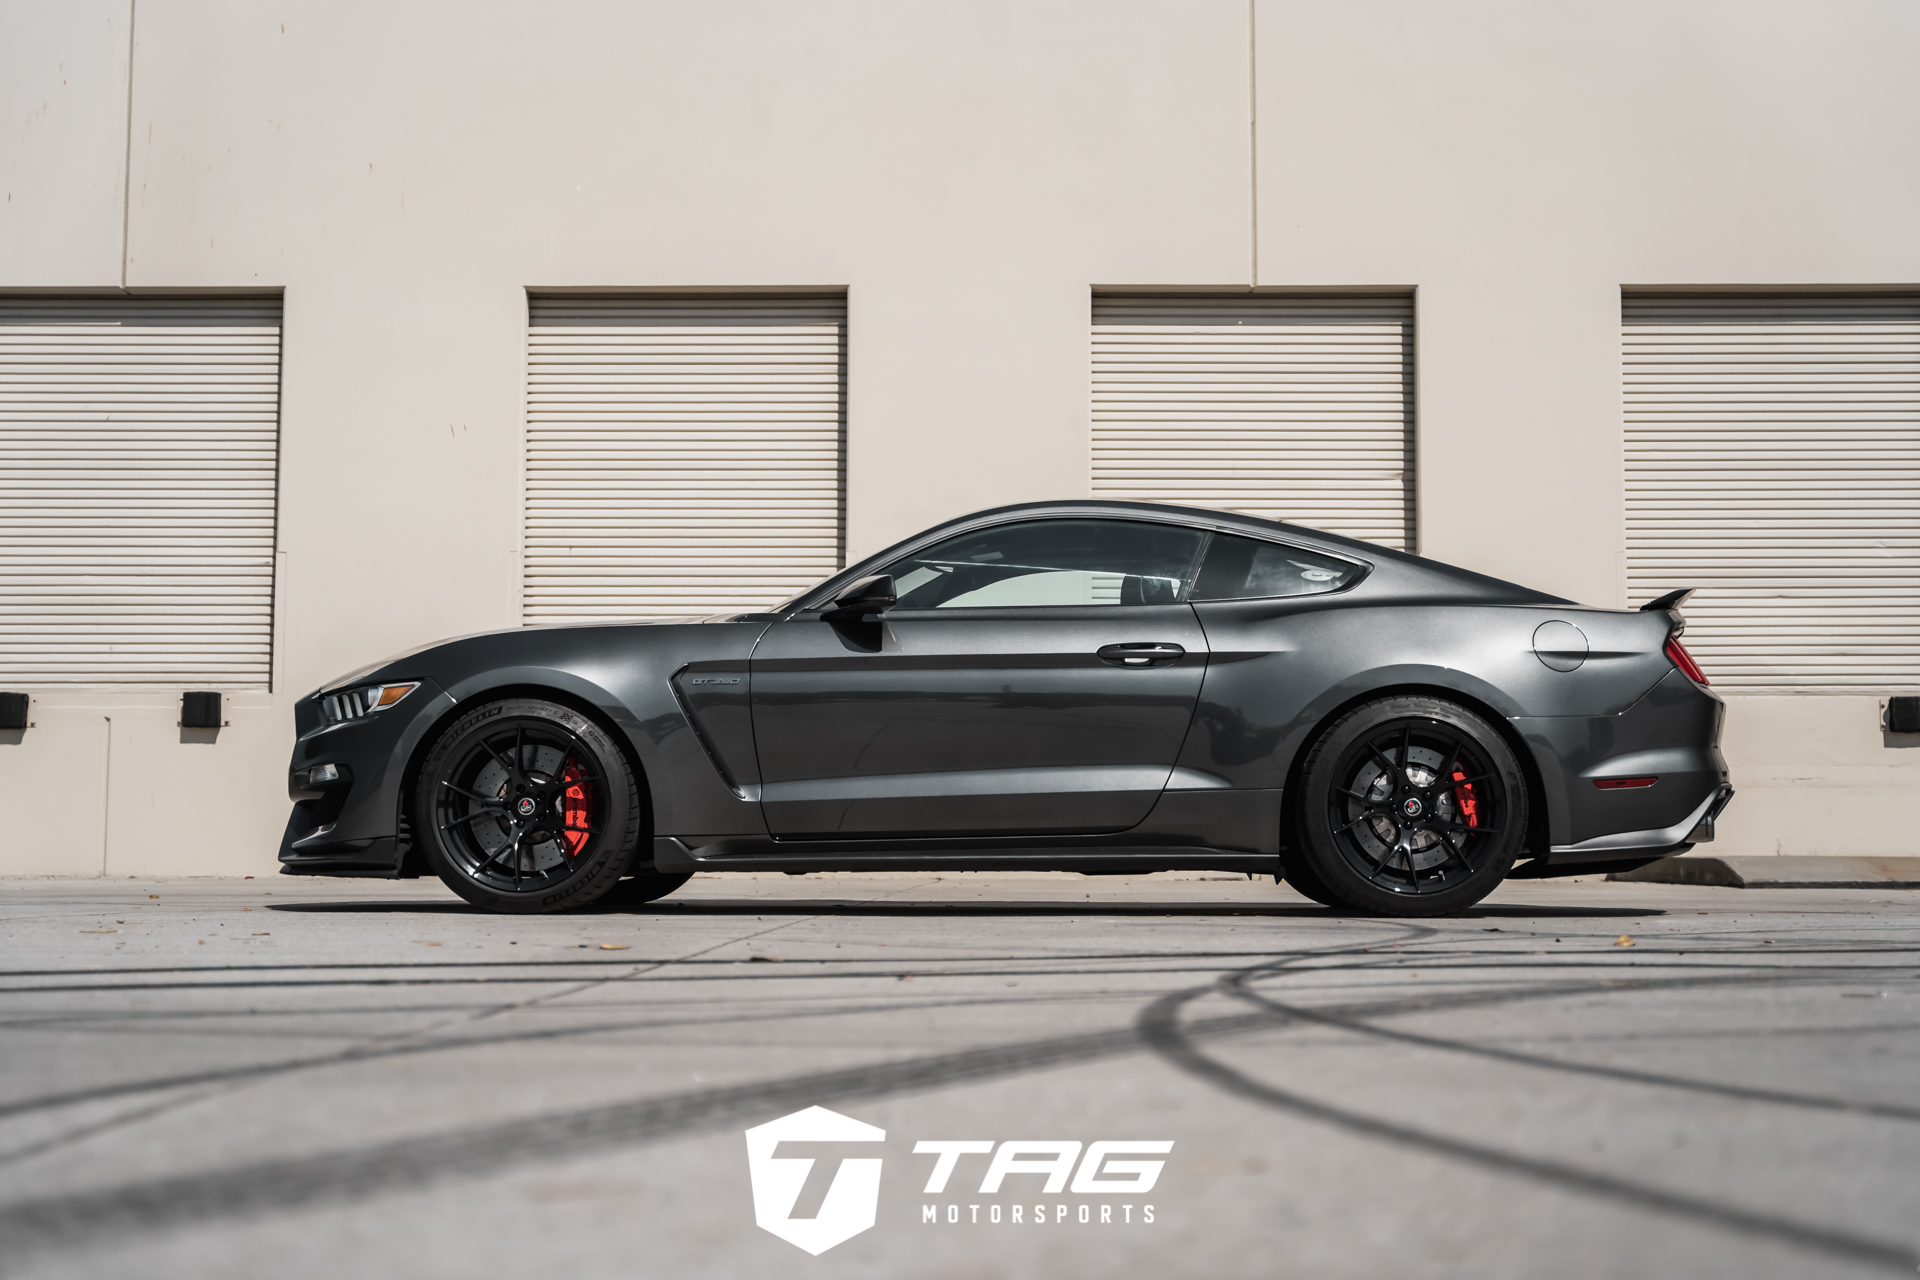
(0, 0, 1920, 873)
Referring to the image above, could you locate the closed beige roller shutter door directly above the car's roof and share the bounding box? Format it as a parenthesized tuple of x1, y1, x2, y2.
(1092, 296, 1413, 551)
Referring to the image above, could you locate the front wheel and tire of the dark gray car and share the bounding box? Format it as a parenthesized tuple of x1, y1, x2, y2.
(413, 699, 645, 913)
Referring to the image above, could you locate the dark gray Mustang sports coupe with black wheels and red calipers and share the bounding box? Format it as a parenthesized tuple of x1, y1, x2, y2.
(280, 503, 1734, 915)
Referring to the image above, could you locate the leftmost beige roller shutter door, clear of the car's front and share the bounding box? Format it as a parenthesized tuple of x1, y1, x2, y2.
(0, 297, 280, 687)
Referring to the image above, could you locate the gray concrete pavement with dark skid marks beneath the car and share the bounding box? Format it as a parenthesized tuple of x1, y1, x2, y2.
(0, 875, 1920, 1280)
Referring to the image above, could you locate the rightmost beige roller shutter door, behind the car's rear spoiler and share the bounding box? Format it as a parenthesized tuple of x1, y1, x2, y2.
(1622, 296, 1920, 695)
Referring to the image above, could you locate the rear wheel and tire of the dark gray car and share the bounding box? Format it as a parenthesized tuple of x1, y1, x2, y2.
(1286, 697, 1526, 915)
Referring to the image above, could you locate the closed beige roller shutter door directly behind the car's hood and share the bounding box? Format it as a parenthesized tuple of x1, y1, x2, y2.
(524, 297, 847, 622)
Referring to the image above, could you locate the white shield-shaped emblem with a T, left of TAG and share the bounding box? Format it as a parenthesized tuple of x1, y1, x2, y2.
(747, 1107, 887, 1257)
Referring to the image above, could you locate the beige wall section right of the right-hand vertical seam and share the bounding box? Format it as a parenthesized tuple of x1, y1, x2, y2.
(1256, 0, 1920, 854)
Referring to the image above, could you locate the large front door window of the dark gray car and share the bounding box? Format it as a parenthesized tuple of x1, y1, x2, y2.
(887, 520, 1206, 608)
